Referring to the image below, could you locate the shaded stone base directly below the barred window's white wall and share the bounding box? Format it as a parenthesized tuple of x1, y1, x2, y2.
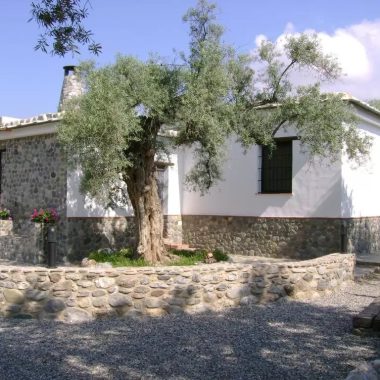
(182, 215, 341, 259)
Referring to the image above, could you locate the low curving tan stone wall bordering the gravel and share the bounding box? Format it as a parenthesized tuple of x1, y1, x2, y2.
(0, 254, 355, 322)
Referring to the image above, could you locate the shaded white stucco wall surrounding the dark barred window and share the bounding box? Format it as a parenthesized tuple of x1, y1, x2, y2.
(179, 140, 341, 217)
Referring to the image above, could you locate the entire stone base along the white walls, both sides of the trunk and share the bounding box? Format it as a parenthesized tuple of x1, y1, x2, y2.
(63, 215, 380, 261)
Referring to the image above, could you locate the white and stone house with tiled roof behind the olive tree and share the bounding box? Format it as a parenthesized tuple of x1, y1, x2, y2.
(0, 69, 380, 258)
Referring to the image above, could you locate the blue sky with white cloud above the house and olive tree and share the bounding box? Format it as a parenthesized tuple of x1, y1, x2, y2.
(0, 0, 380, 117)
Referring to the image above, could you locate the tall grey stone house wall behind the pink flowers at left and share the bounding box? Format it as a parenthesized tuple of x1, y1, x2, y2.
(0, 135, 67, 259)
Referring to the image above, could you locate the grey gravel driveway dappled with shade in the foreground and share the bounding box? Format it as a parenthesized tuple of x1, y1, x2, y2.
(0, 280, 380, 380)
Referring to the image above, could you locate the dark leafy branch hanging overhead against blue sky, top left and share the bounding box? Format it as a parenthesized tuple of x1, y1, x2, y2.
(29, 0, 102, 56)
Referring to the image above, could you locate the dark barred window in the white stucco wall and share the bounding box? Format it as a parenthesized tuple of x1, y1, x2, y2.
(261, 139, 293, 193)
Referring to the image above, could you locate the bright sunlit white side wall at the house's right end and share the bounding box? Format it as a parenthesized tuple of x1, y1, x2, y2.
(341, 111, 380, 218)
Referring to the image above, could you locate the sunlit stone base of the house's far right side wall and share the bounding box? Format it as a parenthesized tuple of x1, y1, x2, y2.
(344, 216, 380, 255)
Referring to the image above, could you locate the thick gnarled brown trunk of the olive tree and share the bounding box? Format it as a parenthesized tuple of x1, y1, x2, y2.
(126, 151, 165, 263)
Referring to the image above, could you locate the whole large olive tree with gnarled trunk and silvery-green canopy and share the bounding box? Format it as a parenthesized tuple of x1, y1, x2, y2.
(59, 0, 370, 262)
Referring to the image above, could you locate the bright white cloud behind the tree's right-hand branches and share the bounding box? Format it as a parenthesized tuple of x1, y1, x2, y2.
(256, 20, 380, 100)
